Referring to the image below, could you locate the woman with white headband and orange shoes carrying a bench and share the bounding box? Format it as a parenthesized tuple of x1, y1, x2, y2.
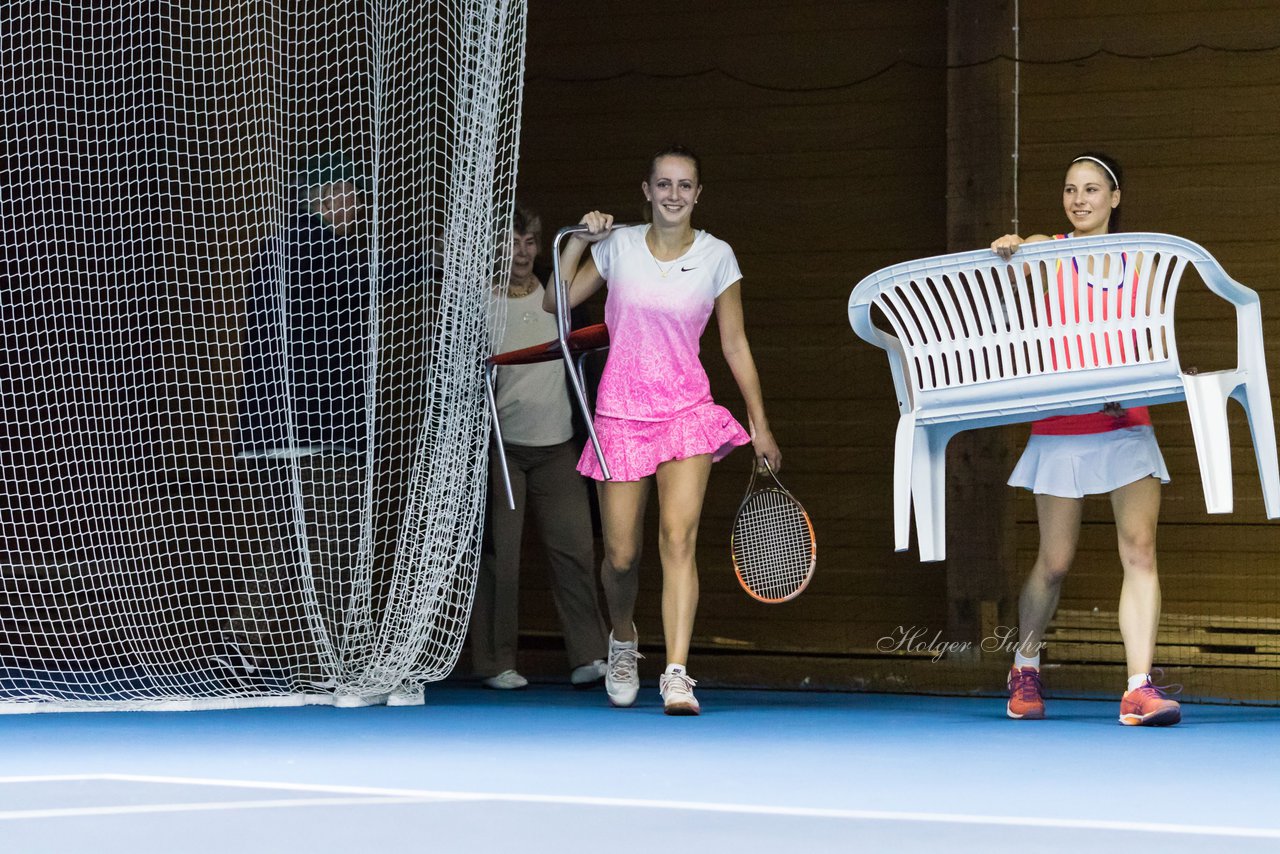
(991, 154, 1181, 726)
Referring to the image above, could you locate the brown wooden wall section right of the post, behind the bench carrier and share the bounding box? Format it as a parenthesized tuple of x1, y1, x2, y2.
(1015, 0, 1280, 699)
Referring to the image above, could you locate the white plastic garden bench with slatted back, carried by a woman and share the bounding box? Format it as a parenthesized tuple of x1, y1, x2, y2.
(849, 232, 1280, 561)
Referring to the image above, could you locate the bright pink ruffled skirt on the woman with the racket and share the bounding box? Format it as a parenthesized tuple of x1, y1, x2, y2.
(577, 403, 751, 480)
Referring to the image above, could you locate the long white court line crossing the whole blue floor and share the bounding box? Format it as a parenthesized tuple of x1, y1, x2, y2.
(0, 773, 1280, 839)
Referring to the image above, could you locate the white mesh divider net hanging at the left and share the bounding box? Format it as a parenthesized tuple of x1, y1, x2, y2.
(0, 0, 525, 711)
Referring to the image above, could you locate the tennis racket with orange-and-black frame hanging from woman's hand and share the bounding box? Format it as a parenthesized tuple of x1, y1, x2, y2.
(730, 460, 818, 603)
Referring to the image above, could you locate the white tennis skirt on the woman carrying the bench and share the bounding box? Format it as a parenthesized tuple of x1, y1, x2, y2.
(1009, 425, 1169, 498)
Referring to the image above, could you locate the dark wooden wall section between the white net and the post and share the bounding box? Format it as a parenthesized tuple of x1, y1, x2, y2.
(520, 0, 946, 653)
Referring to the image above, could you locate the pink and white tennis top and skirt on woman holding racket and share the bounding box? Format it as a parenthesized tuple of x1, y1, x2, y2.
(577, 225, 751, 480)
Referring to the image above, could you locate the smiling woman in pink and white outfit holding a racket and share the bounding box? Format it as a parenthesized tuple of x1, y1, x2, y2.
(544, 146, 782, 714)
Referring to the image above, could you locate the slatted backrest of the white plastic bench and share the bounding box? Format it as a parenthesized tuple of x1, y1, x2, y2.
(850, 233, 1207, 403)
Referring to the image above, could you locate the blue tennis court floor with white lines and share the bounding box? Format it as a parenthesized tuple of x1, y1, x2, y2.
(0, 682, 1280, 854)
